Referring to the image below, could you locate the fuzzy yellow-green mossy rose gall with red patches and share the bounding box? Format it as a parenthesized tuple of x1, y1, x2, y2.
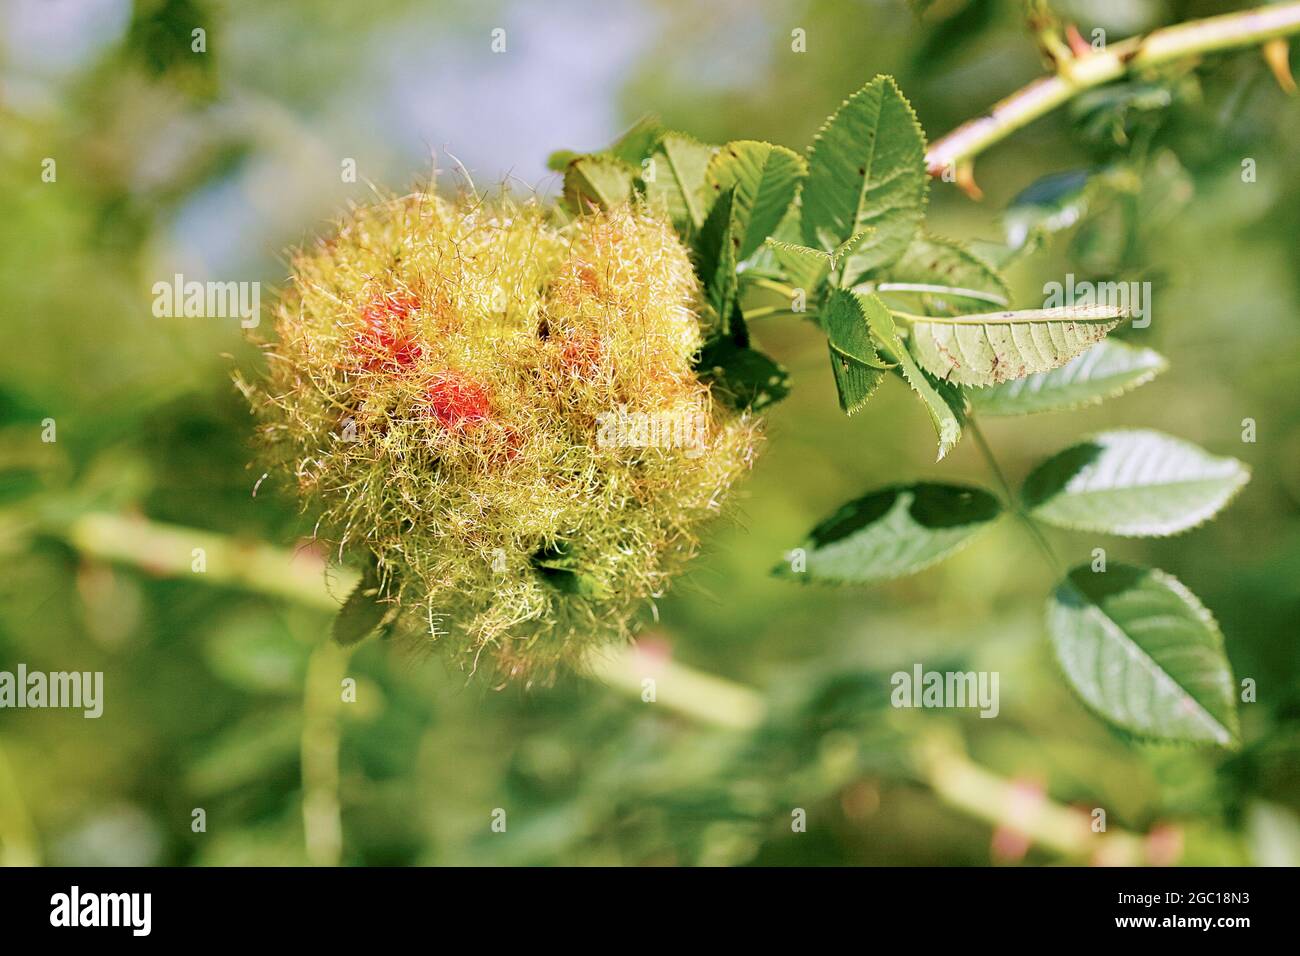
(248, 193, 757, 679)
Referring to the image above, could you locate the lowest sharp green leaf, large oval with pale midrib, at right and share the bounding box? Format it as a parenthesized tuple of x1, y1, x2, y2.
(1048, 563, 1238, 747)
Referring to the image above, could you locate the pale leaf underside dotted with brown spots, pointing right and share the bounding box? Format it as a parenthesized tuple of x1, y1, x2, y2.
(909, 306, 1125, 385)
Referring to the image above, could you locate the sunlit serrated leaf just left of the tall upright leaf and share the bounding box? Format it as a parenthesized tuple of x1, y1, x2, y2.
(705, 139, 806, 261)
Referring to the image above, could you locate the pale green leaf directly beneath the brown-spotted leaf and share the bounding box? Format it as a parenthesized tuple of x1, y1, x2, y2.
(970, 338, 1169, 415)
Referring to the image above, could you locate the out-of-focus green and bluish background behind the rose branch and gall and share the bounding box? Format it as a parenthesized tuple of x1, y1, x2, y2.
(0, 0, 1300, 865)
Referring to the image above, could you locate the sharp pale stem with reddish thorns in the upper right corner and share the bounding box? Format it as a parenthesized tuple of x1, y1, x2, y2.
(926, 1, 1300, 176)
